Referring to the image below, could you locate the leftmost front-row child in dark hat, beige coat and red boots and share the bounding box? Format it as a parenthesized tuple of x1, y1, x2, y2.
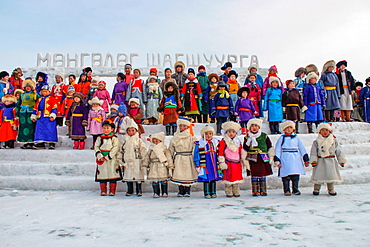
(95, 121, 122, 196)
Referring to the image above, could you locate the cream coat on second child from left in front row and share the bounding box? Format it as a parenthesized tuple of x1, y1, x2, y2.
(117, 133, 147, 182)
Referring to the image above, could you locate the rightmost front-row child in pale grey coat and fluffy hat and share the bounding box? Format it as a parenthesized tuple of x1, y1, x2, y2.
(310, 123, 347, 196)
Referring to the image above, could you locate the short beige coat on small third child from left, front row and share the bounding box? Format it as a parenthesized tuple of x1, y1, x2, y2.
(142, 143, 173, 181)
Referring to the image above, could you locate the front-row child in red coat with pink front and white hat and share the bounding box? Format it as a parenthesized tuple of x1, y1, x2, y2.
(217, 122, 243, 197)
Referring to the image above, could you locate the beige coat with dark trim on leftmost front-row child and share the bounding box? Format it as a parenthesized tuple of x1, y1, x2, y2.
(94, 136, 122, 182)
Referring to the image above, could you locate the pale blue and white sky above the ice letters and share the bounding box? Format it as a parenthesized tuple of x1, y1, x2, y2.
(0, 0, 370, 81)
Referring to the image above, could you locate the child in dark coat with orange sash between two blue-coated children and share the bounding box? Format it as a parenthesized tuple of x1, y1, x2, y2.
(283, 80, 307, 134)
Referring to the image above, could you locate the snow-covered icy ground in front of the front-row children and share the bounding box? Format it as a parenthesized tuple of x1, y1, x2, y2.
(0, 184, 370, 247)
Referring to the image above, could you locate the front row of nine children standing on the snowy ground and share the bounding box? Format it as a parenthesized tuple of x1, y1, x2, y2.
(95, 117, 346, 198)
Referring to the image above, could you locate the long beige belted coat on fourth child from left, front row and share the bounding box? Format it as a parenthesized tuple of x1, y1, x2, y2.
(168, 129, 198, 186)
